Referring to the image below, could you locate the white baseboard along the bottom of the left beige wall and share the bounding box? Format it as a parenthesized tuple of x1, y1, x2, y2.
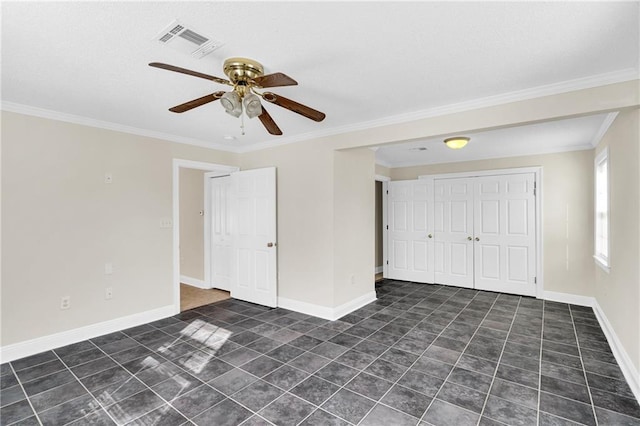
(0, 305, 175, 363)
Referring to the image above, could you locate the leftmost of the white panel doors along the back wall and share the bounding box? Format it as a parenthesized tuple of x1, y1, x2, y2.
(385, 179, 434, 283)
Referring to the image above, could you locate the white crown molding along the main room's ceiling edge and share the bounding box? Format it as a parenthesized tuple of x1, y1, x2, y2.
(0, 68, 638, 153)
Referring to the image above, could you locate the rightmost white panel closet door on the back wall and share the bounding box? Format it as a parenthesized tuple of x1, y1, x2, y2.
(474, 173, 536, 296)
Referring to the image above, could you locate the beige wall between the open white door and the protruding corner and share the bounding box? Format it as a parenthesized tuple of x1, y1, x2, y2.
(241, 141, 338, 307)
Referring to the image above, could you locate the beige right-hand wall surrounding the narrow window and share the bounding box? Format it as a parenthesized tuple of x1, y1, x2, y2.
(591, 110, 640, 371)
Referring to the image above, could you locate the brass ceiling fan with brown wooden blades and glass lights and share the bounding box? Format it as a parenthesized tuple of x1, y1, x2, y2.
(149, 58, 325, 135)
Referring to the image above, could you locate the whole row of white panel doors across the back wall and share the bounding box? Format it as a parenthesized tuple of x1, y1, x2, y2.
(387, 173, 536, 296)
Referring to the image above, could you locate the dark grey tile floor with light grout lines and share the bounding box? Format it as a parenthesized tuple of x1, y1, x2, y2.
(0, 281, 640, 426)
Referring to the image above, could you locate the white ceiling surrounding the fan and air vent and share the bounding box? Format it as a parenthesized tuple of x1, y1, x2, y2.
(2, 1, 640, 163)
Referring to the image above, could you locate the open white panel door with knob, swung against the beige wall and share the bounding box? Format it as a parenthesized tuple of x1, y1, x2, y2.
(230, 167, 277, 307)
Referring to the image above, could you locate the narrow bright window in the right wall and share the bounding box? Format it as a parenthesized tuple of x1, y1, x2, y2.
(593, 148, 610, 272)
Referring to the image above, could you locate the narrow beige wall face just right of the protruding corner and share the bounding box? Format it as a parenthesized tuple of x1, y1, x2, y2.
(333, 148, 375, 306)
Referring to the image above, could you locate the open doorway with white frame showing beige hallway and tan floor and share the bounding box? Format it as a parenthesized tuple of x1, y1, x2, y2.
(173, 159, 238, 312)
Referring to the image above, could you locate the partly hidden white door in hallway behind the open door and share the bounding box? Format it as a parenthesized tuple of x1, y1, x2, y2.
(209, 176, 232, 291)
